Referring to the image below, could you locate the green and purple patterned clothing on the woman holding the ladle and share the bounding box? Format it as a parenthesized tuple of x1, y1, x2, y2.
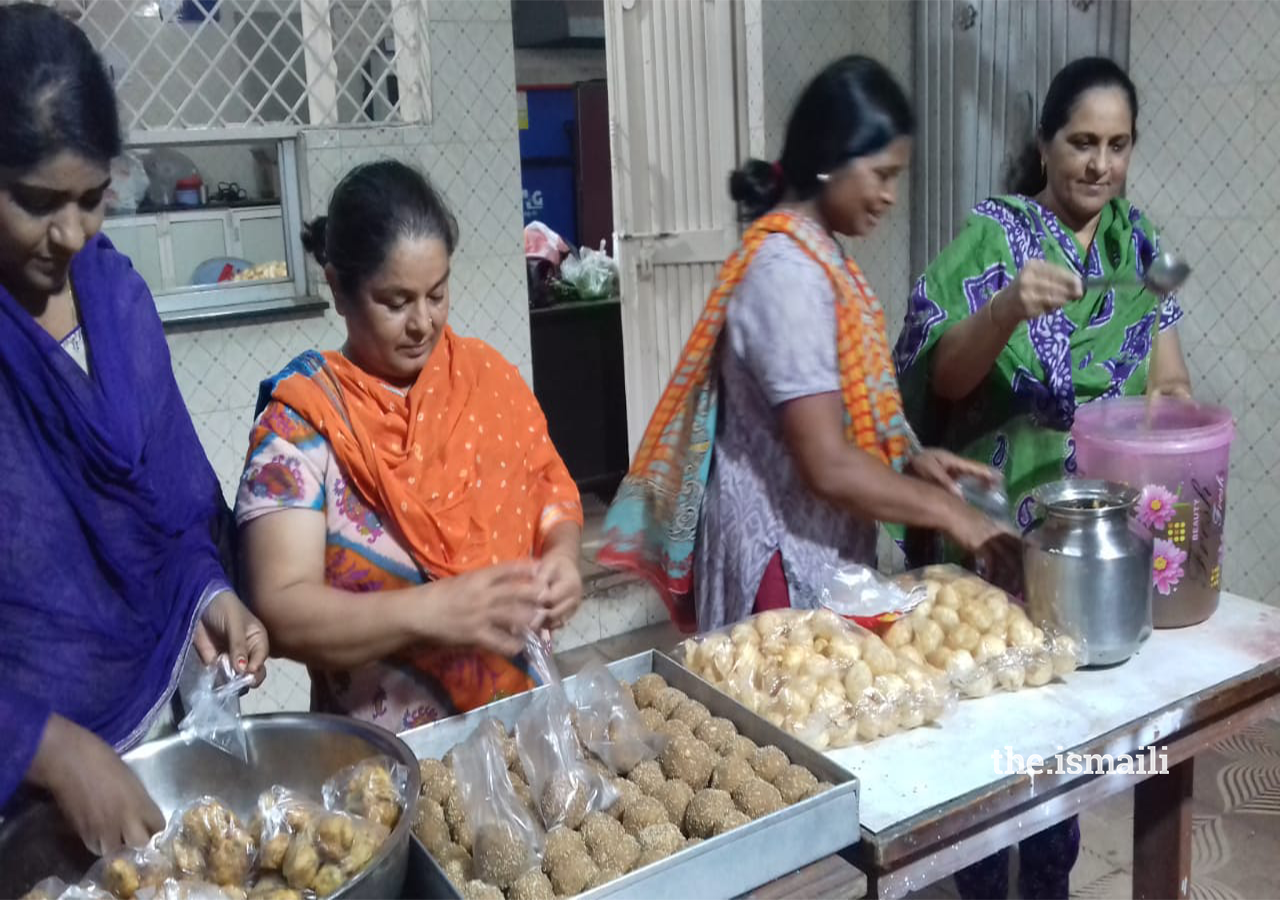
(895, 195, 1183, 542)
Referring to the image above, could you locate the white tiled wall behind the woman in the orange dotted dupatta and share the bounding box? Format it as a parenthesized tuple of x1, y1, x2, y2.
(169, 0, 531, 712)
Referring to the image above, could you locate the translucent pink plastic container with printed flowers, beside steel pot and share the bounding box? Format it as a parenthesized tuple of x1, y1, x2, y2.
(1071, 397, 1235, 629)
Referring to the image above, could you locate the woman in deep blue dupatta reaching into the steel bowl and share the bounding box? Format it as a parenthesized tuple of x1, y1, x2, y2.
(0, 4, 268, 853)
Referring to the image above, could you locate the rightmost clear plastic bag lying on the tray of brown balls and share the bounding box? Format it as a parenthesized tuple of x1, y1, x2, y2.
(575, 662, 667, 775)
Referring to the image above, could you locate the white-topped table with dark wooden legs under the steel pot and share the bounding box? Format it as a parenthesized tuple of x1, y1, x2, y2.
(828, 594, 1280, 897)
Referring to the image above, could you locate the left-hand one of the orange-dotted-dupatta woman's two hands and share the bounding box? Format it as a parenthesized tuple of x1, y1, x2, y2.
(424, 561, 544, 657)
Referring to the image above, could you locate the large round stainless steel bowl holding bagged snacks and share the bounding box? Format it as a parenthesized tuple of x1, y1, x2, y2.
(0, 713, 420, 900)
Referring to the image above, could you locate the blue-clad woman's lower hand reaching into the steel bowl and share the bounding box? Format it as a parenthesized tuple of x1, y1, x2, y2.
(28, 714, 164, 856)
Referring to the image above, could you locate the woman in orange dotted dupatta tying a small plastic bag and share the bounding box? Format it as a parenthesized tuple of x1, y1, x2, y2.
(236, 161, 582, 731)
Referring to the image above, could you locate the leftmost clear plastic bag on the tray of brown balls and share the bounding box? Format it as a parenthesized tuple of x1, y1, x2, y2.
(452, 723, 545, 887)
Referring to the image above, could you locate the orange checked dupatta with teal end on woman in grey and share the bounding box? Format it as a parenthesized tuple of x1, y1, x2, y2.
(599, 213, 914, 631)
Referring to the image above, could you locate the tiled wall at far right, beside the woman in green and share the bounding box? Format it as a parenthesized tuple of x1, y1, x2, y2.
(1129, 3, 1280, 603)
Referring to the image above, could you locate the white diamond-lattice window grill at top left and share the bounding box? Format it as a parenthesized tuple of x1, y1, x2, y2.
(55, 0, 430, 143)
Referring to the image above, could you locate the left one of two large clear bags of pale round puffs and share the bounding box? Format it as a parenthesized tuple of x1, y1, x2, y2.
(682, 609, 955, 750)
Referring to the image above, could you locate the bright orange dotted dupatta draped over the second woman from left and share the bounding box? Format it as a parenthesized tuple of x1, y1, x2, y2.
(266, 328, 582, 712)
